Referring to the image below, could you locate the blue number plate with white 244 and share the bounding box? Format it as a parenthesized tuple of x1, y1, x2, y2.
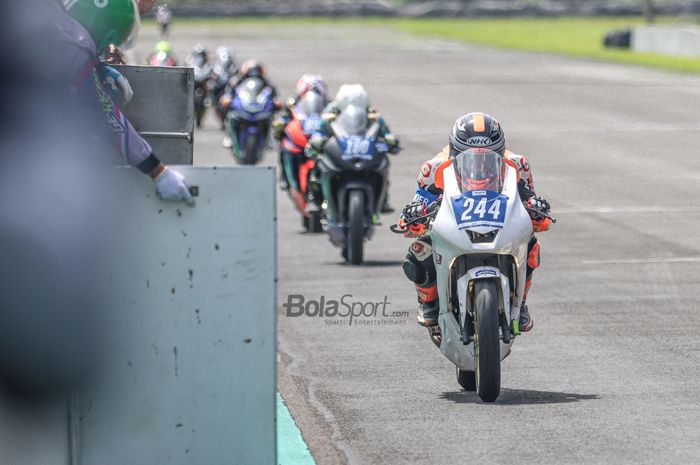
(450, 191, 508, 229)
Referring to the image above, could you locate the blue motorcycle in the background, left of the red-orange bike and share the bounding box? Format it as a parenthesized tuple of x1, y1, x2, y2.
(227, 77, 275, 165)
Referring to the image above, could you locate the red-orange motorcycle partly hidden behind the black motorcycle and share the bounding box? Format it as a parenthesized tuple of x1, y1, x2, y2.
(280, 91, 325, 232)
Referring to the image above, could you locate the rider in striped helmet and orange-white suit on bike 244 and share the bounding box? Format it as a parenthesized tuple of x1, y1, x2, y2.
(399, 113, 551, 332)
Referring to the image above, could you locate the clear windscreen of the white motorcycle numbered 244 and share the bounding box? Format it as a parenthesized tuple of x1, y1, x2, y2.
(452, 149, 505, 193)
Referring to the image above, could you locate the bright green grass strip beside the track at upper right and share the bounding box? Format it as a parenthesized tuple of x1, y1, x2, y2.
(389, 18, 700, 73)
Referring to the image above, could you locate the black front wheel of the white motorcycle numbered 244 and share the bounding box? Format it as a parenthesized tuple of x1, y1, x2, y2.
(474, 279, 501, 402)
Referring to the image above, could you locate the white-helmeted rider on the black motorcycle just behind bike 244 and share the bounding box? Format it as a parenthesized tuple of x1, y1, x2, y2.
(306, 84, 401, 213)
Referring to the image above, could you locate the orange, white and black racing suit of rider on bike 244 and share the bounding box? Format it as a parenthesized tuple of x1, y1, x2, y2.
(399, 147, 551, 332)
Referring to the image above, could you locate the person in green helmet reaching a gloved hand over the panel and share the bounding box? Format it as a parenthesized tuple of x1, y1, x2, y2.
(52, 0, 194, 206)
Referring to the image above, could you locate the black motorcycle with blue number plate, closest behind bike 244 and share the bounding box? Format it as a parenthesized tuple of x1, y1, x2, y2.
(316, 104, 389, 265)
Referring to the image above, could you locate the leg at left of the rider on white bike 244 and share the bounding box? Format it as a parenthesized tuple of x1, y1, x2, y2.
(403, 236, 440, 326)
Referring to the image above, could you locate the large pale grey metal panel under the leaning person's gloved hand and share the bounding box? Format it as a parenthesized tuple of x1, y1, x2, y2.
(73, 167, 277, 465)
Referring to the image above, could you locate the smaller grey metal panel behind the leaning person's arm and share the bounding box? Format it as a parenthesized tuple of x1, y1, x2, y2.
(116, 65, 194, 165)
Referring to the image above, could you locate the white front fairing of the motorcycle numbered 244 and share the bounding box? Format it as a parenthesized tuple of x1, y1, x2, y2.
(430, 161, 533, 371)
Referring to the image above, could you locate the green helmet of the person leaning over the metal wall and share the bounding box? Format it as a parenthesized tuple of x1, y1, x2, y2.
(63, 0, 140, 52)
